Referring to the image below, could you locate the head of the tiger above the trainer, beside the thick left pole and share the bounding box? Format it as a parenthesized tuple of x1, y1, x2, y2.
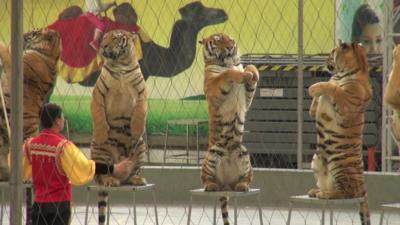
(23, 28, 61, 59)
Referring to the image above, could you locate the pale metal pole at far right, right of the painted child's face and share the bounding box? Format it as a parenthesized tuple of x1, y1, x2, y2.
(381, 1, 393, 171)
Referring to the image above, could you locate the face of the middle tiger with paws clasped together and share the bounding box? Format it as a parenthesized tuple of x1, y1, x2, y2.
(199, 33, 240, 67)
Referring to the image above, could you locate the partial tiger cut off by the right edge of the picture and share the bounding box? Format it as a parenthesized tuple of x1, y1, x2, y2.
(384, 45, 400, 145)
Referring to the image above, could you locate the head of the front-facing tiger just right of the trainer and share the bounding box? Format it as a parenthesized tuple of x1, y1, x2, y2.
(99, 30, 137, 62)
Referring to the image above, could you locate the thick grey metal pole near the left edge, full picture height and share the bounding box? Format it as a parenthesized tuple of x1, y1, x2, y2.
(10, 0, 23, 225)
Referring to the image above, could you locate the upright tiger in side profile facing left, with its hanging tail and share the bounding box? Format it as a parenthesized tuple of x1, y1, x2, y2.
(308, 43, 372, 225)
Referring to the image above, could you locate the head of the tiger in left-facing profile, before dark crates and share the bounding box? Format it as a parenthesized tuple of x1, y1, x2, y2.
(327, 43, 368, 73)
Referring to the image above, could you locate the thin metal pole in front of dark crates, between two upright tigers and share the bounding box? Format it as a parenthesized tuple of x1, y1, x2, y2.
(297, 0, 304, 169)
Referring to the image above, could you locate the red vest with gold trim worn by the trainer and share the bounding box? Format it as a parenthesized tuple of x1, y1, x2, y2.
(24, 129, 71, 203)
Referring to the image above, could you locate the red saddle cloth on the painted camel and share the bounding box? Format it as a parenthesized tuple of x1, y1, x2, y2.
(48, 13, 140, 68)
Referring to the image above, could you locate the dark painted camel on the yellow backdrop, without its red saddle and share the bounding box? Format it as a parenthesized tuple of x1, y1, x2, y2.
(52, 1, 228, 86)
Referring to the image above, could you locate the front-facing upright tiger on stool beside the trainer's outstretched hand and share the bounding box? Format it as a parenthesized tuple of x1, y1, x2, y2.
(91, 30, 147, 224)
